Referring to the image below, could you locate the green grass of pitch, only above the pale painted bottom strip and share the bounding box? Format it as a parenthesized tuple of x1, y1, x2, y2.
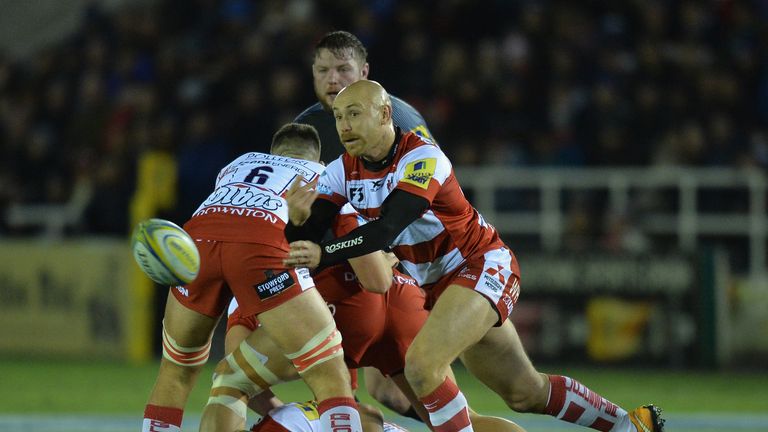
(0, 360, 768, 414)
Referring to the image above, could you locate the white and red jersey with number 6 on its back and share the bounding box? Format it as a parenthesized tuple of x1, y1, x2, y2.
(184, 152, 325, 248)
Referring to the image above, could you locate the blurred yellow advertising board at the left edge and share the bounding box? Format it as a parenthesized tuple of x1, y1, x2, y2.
(0, 239, 149, 360)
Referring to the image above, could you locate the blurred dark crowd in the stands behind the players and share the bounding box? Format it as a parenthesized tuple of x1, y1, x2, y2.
(0, 0, 768, 243)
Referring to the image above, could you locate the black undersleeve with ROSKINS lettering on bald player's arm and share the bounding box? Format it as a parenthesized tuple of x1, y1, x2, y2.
(313, 189, 429, 266)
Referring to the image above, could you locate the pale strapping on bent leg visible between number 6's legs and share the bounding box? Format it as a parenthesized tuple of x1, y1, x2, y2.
(211, 341, 281, 398)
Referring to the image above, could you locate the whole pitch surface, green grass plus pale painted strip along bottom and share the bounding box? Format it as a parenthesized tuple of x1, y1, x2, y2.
(0, 359, 768, 432)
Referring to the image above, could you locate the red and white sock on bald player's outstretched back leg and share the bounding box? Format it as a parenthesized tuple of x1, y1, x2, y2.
(544, 375, 627, 432)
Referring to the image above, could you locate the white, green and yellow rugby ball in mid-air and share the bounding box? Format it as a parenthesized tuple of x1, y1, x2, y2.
(131, 218, 200, 285)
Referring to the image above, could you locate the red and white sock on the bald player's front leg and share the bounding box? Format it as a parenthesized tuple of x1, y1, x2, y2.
(419, 378, 472, 432)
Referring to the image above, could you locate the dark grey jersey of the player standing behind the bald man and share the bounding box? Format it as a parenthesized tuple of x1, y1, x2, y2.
(294, 95, 432, 163)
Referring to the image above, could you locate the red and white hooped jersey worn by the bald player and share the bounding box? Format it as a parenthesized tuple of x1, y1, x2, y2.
(318, 132, 504, 286)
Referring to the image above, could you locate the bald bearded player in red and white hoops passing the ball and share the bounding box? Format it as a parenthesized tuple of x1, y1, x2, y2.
(285, 80, 663, 432)
